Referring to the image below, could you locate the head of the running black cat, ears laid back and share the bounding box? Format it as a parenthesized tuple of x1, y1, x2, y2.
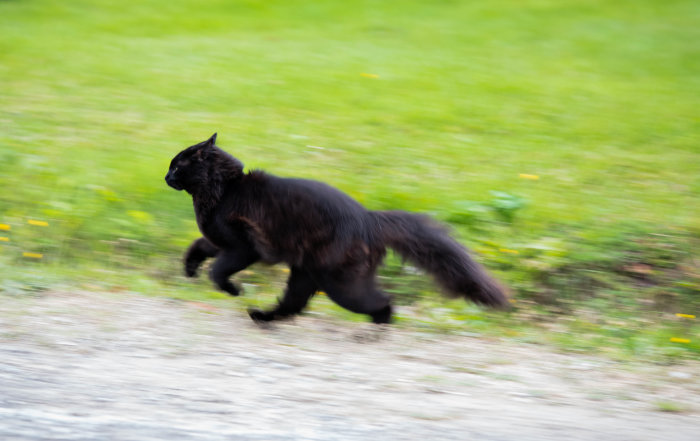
(165, 133, 243, 194)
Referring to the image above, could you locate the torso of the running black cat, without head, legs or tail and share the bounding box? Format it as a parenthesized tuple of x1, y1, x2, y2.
(195, 171, 379, 269)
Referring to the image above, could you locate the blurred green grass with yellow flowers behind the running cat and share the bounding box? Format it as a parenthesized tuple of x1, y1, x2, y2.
(0, 0, 700, 357)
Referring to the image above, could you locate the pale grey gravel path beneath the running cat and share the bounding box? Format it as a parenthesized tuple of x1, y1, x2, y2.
(0, 292, 700, 441)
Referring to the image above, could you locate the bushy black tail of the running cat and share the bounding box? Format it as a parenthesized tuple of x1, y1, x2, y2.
(371, 211, 510, 308)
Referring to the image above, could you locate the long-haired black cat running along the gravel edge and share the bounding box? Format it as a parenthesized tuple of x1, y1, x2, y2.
(165, 134, 508, 323)
